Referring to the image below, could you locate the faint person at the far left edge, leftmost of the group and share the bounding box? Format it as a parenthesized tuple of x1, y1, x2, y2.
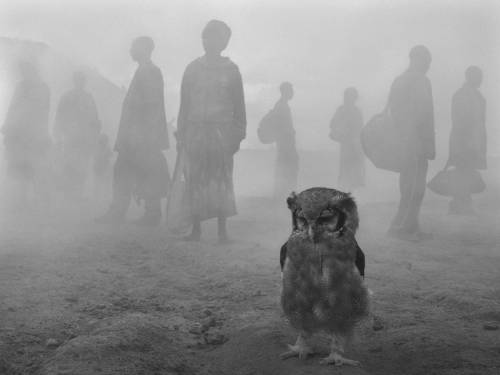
(2, 61, 51, 209)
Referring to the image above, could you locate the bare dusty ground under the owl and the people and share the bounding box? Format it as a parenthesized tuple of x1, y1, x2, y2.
(0, 192, 500, 375)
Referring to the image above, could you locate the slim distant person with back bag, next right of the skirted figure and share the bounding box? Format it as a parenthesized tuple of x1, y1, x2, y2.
(272, 82, 299, 202)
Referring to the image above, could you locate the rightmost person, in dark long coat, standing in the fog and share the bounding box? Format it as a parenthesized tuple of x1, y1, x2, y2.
(447, 66, 486, 214)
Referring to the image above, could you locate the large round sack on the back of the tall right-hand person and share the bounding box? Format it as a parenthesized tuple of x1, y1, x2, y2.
(361, 112, 407, 173)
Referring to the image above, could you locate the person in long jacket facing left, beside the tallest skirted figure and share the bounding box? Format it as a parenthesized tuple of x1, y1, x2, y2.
(100, 36, 169, 226)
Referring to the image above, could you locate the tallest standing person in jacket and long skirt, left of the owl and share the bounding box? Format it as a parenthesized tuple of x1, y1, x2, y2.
(177, 20, 246, 242)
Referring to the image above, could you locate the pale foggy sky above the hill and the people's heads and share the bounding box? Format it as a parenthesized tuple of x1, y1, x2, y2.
(0, 0, 500, 153)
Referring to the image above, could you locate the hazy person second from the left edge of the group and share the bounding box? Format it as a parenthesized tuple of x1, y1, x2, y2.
(54, 72, 101, 198)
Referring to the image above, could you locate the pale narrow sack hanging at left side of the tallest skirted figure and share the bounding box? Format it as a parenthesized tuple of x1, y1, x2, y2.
(165, 150, 191, 233)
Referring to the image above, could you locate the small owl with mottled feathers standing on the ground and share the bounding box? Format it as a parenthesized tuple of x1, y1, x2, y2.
(280, 188, 368, 366)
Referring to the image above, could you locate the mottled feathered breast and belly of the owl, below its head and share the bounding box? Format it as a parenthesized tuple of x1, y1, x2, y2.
(282, 235, 367, 330)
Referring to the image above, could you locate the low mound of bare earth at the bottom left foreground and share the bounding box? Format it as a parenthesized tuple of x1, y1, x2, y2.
(40, 313, 202, 375)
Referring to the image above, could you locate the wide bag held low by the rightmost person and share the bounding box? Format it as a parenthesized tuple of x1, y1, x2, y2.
(427, 169, 486, 196)
